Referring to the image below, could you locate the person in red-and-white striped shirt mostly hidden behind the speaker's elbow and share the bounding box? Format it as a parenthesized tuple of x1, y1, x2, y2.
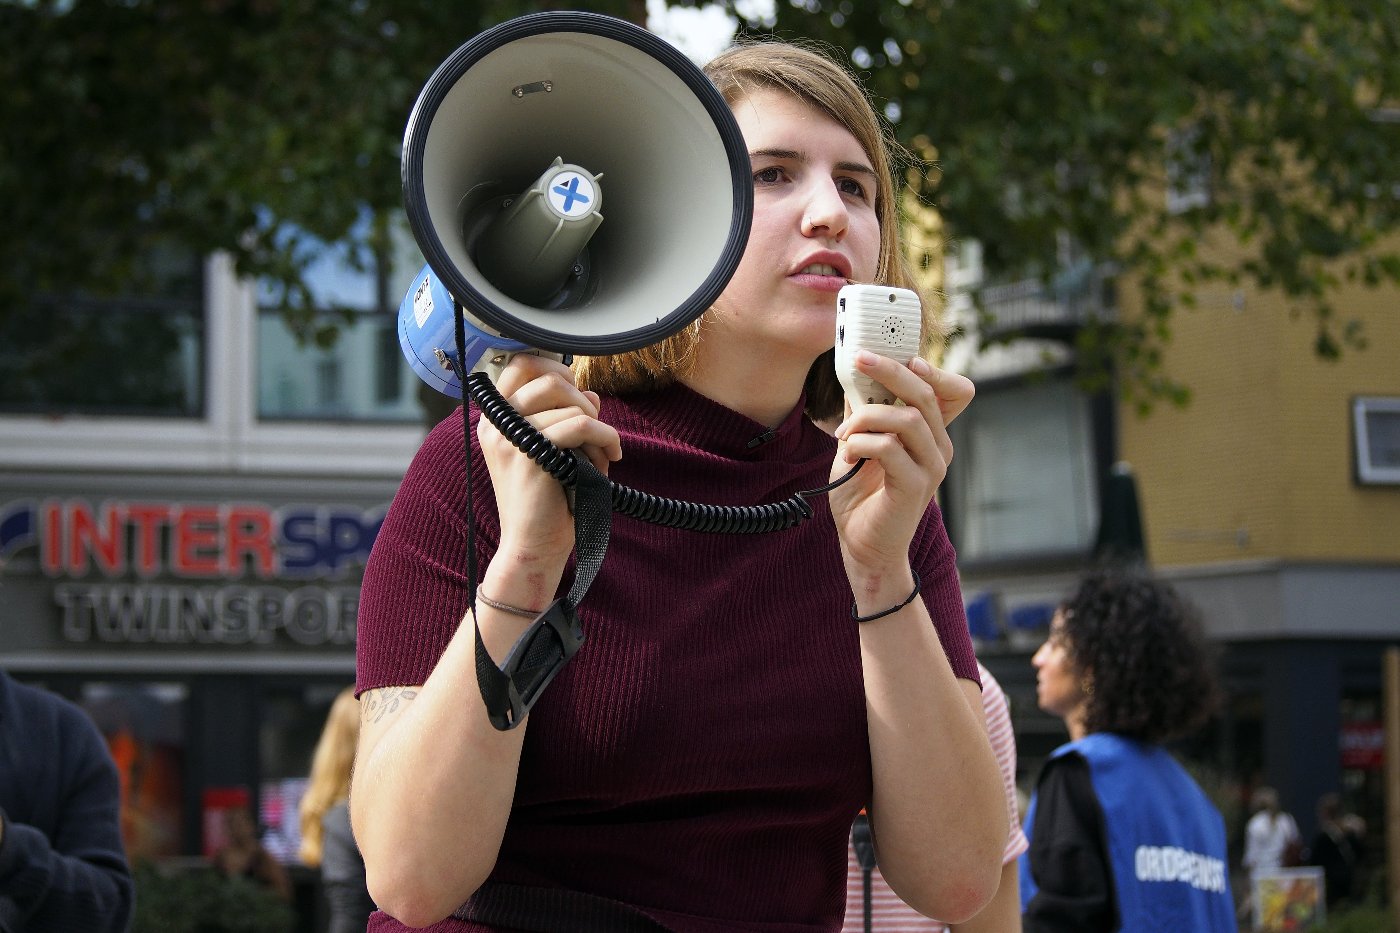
(841, 661, 1026, 933)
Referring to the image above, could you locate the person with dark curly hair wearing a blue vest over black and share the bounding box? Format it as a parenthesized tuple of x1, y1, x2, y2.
(1021, 569, 1236, 933)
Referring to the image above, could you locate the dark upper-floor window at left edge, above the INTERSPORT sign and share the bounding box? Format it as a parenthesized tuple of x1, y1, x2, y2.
(0, 248, 206, 417)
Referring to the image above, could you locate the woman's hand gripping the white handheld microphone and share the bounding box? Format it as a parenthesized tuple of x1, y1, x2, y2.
(830, 350, 974, 565)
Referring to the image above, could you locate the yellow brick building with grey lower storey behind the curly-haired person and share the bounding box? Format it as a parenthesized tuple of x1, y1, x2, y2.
(948, 233, 1400, 885)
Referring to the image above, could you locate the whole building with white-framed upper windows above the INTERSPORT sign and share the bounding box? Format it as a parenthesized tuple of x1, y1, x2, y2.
(0, 246, 426, 913)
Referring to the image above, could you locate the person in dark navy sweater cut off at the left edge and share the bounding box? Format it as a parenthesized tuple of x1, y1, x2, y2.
(0, 671, 134, 933)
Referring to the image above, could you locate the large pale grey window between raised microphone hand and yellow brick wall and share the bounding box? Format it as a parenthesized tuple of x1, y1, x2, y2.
(945, 377, 1098, 560)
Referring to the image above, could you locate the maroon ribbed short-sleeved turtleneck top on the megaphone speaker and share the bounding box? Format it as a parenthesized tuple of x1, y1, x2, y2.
(357, 385, 977, 933)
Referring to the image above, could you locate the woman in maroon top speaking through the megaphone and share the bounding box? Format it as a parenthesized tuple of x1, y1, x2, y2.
(350, 43, 1007, 933)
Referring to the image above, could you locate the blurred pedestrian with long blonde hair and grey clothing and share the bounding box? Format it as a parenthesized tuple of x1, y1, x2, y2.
(300, 686, 374, 933)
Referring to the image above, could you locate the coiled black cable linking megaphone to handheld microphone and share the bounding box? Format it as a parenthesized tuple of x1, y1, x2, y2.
(462, 373, 865, 534)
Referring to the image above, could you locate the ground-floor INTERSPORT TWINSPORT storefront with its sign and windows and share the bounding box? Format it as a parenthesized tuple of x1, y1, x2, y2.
(0, 471, 395, 860)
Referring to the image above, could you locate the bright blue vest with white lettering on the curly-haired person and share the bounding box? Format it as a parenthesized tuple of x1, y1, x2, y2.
(1021, 733, 1236, 933)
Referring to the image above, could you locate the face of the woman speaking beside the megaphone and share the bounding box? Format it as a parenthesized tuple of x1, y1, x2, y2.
(715, 90, 881, 359)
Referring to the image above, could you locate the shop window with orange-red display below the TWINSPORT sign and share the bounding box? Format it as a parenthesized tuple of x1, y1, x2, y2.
(78, 681, 188, 863)
